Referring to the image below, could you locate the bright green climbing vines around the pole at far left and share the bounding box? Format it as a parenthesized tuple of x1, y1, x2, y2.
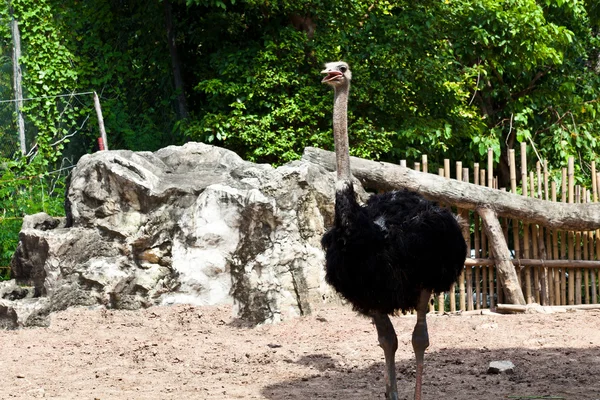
(0, 0, 76, 279)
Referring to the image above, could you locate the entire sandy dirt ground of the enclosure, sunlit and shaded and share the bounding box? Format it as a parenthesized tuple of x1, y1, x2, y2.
(0, 305, 600, 400)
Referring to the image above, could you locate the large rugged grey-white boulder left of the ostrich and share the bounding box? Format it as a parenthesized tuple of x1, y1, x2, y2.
(0, 143, 352, 327)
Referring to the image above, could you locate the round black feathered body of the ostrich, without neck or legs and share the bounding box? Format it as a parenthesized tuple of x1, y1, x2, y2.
(322, 185, 467, 315)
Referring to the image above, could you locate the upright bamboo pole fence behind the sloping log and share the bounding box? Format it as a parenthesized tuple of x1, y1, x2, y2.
(401, 143, 600, 314)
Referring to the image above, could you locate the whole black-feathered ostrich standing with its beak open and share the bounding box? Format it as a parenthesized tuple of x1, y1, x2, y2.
(321, 61, 467, 400)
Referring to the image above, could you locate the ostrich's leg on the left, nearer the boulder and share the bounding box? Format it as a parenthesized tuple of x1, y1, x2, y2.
(371, 312, 398, 400)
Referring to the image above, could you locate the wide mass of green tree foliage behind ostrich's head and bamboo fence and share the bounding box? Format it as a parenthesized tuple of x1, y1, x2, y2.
(182, 0, 600, 180)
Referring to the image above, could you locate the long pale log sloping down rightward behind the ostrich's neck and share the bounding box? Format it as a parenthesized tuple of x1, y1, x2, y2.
(302, 147, 600, 231)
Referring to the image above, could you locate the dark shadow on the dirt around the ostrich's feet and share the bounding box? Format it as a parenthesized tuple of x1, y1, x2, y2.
(261, 347, 600, 400)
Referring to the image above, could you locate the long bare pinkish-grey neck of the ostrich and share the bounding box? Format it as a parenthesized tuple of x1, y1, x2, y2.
(333, 84, 352, 186)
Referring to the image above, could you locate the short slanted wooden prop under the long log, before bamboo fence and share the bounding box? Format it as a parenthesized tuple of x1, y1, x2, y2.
(477, 207, 526, 304)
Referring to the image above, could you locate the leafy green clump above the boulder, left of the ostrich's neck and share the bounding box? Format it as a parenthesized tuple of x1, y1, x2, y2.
(186, 21, 338, 163)
